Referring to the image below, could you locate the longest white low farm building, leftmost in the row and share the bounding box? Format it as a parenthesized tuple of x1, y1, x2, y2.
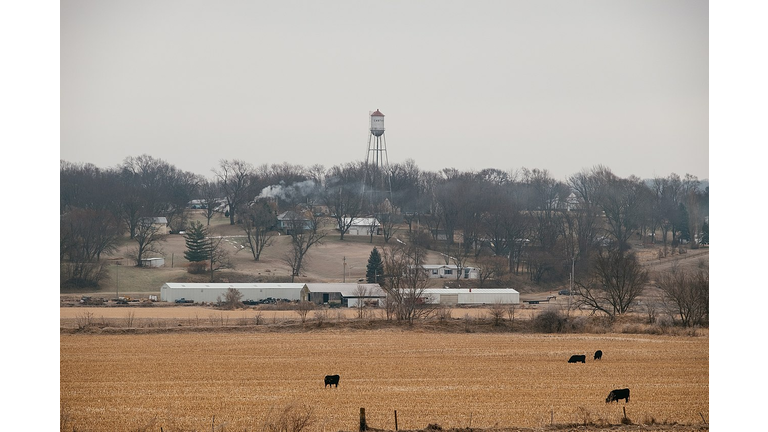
(160, 283, 306, 303)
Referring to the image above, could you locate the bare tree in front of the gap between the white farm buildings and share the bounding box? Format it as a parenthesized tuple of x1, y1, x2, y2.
(383, 242, 429, 324)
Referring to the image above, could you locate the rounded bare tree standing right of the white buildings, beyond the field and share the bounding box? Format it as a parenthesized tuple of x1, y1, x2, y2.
(575, 248, 648, 317)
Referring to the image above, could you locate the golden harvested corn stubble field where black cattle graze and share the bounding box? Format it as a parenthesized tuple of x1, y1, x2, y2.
(60, 330, 709, 431)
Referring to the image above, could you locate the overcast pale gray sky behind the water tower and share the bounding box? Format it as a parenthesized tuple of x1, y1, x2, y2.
(60, 0, 709, 179)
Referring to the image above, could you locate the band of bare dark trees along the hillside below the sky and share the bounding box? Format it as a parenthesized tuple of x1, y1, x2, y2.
(60, 155, 709, 298)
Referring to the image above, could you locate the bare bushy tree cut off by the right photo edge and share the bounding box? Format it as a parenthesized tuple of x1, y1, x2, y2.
(657, 263, 709, 327)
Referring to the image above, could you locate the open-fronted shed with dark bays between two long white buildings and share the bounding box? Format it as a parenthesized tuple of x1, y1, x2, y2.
(301, 282, 386, 307)
